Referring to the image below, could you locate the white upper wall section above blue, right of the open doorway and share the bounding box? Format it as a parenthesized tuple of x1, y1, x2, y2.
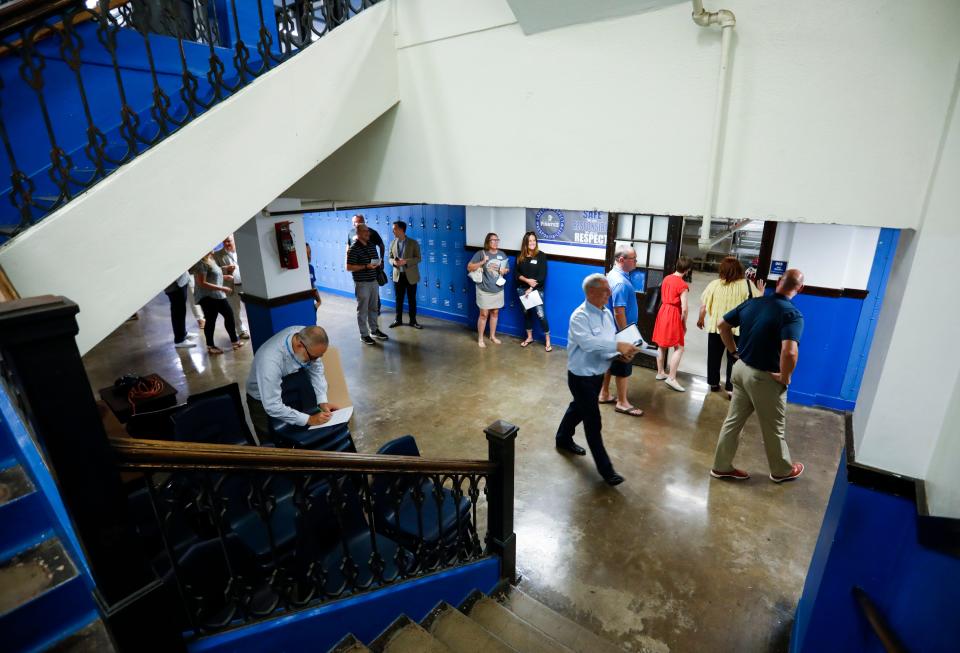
(770, 223, 880, 290)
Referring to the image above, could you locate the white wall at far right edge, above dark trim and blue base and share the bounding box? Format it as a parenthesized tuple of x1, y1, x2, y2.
(854, 62, 960, 500)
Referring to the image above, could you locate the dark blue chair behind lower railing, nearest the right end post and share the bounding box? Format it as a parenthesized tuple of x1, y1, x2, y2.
(373, 435, 470, 555)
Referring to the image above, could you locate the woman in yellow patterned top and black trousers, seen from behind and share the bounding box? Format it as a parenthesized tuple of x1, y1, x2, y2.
(697, 256, 765, 395)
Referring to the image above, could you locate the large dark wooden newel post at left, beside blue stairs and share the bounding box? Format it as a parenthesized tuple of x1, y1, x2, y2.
(0, 296, 185, 651)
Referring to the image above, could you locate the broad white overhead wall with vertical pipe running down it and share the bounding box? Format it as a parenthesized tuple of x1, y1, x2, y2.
(290, 0, 960, 232)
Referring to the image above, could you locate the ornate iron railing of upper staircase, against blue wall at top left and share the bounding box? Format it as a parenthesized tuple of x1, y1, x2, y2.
(0, 0, 378, 240)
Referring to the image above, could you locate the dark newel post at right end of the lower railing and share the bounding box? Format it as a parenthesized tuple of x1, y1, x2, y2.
(483, 420, 520, 585)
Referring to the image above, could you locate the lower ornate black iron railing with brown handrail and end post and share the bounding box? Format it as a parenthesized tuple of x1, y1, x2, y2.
(111, 422, 516, 637)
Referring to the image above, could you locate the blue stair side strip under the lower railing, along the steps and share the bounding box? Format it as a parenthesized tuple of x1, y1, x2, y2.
(189, 557, 500, 653)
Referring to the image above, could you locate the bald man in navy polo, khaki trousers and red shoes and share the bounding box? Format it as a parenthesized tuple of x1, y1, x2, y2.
(710, 269, 803, 483)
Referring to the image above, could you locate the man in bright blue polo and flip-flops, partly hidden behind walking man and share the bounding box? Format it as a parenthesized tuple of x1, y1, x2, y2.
(597, 244, 643, 417)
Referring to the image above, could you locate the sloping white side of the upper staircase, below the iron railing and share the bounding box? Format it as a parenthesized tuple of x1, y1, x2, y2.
(0, 2, 399, 353)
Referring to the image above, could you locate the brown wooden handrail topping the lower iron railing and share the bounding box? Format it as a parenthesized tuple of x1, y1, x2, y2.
(110, 438, 496, 474)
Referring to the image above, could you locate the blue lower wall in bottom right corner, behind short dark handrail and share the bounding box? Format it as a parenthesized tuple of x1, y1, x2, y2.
(790, 453, 960, 653)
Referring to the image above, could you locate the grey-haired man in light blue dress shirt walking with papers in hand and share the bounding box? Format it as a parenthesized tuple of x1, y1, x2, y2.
(556, 274, 639, 485)
